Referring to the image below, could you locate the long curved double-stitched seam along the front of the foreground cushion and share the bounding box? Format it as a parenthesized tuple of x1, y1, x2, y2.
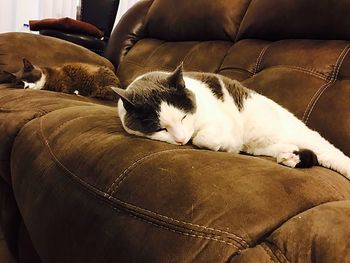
(39, 118, 249, 247)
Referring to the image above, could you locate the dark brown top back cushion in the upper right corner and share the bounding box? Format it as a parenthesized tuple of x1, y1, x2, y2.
(237, 0, 350, 40)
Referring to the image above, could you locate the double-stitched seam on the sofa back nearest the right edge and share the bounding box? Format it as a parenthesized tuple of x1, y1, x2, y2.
(303, 45, 350, 124)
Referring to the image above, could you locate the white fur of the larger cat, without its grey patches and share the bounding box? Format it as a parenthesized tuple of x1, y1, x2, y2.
(118, 77, 350, 179)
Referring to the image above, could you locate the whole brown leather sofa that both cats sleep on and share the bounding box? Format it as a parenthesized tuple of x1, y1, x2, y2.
(0, 0, 350, 263)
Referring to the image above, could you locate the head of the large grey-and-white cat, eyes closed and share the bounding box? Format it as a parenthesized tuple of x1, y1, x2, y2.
(113, 64, 196, 145)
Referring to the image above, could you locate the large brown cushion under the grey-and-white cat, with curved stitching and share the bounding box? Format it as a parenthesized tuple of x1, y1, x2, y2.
(11, 98, 350, 262)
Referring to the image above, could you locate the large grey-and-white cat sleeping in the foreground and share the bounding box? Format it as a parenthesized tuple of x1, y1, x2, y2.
(112, 64, 350, 179)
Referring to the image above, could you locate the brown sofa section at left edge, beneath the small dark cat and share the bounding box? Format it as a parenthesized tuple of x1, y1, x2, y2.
(0, 84, 115, 254)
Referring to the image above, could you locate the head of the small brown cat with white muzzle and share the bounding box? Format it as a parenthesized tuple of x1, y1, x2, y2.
(5, 58, 44, 89)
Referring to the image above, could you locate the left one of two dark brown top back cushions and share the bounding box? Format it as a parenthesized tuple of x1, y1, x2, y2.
(146, 0, 250, 41)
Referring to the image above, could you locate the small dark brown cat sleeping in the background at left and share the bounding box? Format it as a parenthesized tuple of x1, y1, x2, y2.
(0, 59, 120, 100)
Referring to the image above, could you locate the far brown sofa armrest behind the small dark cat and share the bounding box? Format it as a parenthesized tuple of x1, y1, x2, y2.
(0, 32, 114, 72)
